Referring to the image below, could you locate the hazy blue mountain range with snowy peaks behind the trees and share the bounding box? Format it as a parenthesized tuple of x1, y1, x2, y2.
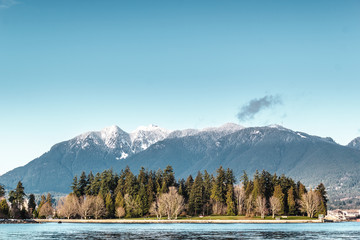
(0, 123, 360, 205)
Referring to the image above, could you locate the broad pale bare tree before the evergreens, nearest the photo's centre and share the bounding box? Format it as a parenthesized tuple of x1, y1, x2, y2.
(159, 187, 184, 219)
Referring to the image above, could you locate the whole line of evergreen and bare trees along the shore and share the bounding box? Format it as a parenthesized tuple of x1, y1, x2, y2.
(0, 166, 327, 221)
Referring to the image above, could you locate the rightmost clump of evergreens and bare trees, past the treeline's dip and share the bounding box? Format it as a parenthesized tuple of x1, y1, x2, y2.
(235, 170, 328, 218)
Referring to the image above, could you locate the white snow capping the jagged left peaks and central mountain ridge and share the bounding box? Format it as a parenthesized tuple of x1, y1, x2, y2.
(64, 123, 244, 160)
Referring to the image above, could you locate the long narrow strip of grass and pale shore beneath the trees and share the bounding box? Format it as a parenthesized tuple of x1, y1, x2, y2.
(36, 216, 320, 224)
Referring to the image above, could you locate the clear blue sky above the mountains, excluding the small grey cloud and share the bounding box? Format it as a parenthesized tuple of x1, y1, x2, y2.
(0, 0, 360, 174)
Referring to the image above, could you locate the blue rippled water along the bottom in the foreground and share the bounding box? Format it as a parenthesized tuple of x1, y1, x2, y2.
(0, 222, 360, 240)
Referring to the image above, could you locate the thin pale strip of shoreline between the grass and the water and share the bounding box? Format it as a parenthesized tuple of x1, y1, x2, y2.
(34, 219, 322, 224)
